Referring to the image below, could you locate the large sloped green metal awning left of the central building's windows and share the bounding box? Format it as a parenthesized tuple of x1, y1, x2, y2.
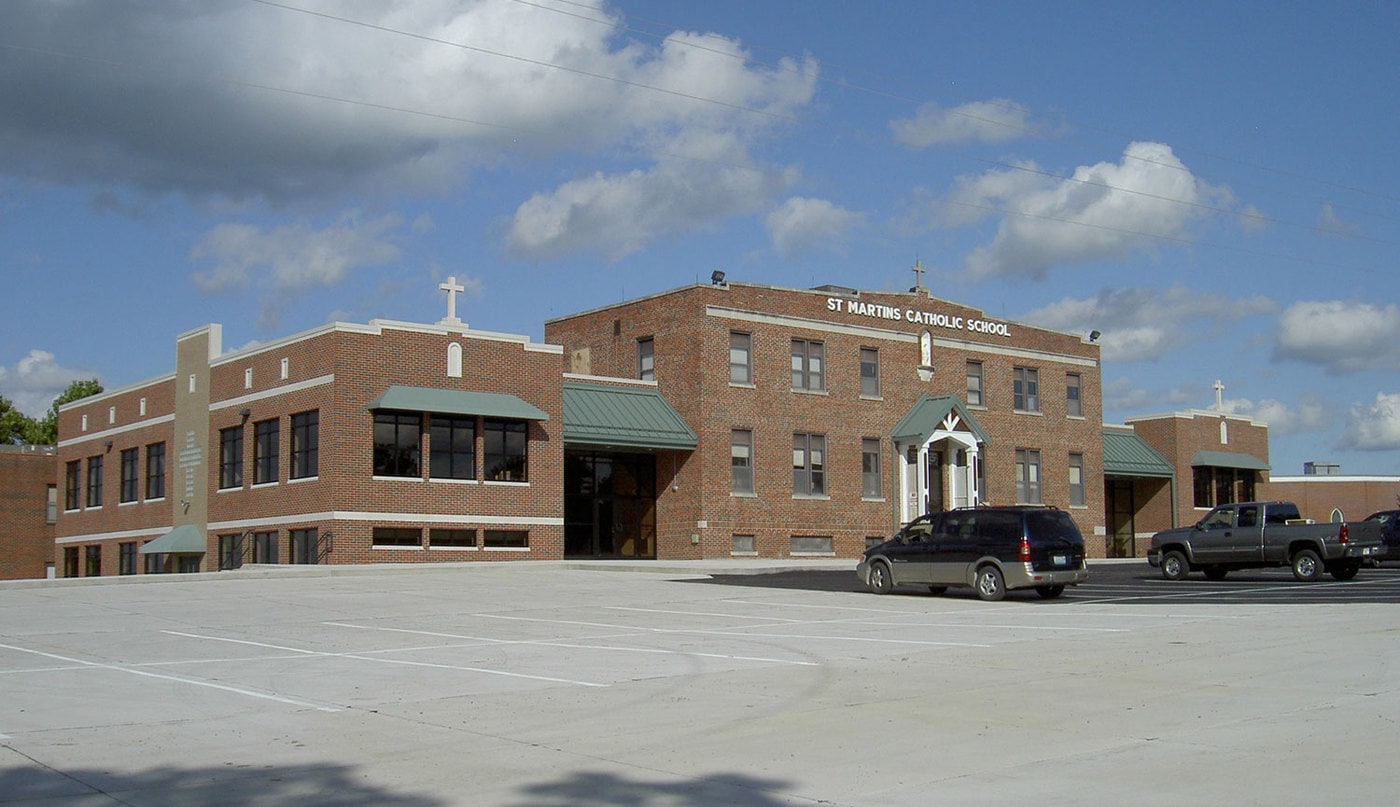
(564, 381, 697, 450)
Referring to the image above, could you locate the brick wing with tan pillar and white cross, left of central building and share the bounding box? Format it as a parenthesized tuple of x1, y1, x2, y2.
(50, 301, 564, 577)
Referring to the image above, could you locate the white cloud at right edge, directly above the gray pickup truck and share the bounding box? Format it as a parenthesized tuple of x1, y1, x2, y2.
(1274, 300, 1400, 375)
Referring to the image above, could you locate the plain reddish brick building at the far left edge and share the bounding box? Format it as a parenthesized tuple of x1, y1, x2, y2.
(0, 444, 59, 580)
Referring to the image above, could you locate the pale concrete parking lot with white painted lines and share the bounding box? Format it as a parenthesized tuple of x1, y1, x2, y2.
(0, 562, 1400, 806)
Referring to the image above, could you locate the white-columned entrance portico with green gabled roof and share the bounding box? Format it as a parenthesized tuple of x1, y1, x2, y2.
(892, 395, 988, 524)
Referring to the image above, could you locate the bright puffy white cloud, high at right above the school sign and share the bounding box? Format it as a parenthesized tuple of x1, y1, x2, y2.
(944, 143, 1229, 279)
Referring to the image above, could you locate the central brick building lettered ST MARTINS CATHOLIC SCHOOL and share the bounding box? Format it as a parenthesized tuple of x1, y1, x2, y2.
(545, 277, 1105, 558)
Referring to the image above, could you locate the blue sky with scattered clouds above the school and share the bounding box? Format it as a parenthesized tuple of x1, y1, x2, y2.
(0, 0, 1400, 475)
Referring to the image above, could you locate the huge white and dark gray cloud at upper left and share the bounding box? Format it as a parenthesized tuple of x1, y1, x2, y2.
(0, 0, 816, 212)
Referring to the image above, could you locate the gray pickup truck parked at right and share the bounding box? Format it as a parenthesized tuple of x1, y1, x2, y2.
(1148, 502, 1383, 581)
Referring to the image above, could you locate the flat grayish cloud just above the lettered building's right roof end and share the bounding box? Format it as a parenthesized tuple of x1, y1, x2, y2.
(1022, 286, 1277, 361)
